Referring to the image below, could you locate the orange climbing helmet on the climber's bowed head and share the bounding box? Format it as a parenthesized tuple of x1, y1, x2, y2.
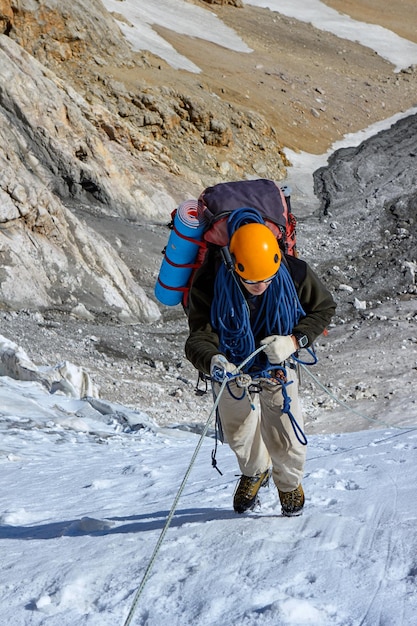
(229, 223, 281, 282)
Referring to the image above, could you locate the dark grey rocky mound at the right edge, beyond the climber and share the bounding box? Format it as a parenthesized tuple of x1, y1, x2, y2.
(314, 115, 417, 308)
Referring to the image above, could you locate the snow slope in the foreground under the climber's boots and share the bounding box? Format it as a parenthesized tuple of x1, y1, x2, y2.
(0, 377, 417, 626)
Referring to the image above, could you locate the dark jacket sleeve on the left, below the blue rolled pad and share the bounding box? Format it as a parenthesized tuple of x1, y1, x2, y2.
(185, 264, 219, 374)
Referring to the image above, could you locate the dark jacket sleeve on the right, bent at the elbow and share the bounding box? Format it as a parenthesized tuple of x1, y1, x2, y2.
(293, 262, 336, 345)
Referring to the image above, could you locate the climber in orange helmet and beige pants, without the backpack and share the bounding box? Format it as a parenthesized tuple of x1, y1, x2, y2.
(185, 217, 335, 516)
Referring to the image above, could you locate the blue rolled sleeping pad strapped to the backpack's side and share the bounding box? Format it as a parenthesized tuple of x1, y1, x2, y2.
(155, 200, 206, 306)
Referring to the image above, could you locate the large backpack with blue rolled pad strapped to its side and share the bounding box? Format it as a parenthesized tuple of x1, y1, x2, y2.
(155, 178, 297, 309)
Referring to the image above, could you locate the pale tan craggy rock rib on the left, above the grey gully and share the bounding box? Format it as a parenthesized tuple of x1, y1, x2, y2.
(0, 36, 179, 219)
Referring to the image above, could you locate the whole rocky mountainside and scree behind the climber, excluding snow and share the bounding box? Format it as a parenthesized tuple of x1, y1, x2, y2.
(0, 0, 417, 433)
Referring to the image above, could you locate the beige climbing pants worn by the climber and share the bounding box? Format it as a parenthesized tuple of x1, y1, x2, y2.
(214, 367, 307, 491)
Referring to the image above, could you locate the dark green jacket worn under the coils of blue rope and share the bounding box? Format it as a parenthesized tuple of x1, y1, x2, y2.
(185, 251, 336, 374)
